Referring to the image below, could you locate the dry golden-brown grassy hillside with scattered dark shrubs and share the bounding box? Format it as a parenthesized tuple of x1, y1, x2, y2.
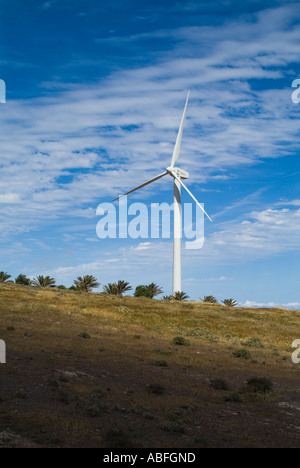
(0, 284, 300, 448)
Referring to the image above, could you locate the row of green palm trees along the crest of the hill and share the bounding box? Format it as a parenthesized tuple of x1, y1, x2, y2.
(0, 271, 238, 307)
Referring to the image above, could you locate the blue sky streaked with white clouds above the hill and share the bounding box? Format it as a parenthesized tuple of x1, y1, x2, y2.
(0, 0, 300, 309)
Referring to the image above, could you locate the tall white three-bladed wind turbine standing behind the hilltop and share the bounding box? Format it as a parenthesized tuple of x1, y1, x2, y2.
(113, 91, 212, 294)
